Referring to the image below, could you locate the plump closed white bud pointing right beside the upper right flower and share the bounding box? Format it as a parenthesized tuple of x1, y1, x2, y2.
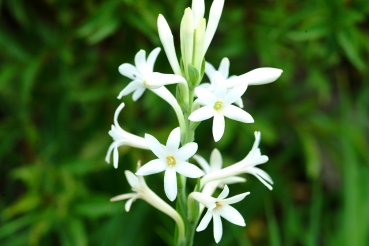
(239, 67, 283, 85)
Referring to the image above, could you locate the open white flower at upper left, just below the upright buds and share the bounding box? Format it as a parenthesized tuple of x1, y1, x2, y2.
(118, 48, 186, 101)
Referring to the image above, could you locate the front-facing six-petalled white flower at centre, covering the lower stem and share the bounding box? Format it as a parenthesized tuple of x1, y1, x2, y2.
(136, 127, 204, 201)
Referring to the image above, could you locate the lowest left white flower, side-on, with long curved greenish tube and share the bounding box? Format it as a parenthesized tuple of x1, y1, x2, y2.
(110, 165, 184, 239)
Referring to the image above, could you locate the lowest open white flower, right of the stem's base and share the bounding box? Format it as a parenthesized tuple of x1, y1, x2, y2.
(189, 185, 250, 243)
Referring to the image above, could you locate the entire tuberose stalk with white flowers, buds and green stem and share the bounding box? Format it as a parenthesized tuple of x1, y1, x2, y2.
(105, 0, 282, 245)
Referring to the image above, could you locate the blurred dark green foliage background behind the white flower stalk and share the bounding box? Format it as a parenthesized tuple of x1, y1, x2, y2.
(0, 0, 369, 246)
